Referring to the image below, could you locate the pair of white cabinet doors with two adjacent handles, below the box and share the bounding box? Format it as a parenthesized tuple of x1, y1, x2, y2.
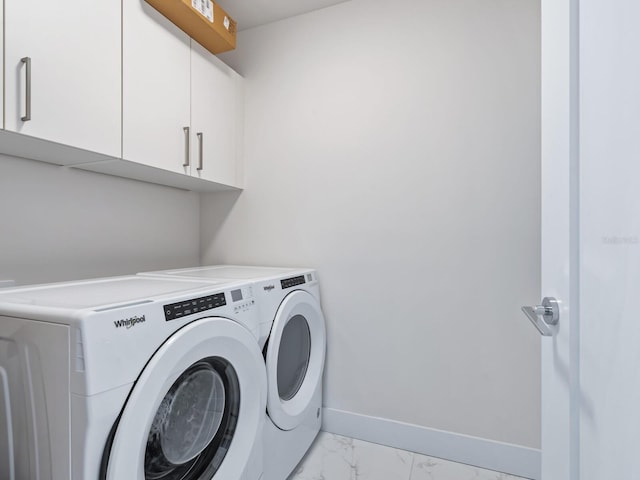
(122, 8, 244, 187)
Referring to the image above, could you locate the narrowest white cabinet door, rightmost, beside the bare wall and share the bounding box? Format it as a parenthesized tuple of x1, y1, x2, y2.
(191, 40, 244, 186)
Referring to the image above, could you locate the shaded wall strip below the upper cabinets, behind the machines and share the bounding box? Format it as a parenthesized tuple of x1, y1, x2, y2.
(0, 155, 200, 284)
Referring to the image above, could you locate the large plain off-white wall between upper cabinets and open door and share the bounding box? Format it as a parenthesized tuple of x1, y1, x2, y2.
(201, 0, 540, 447)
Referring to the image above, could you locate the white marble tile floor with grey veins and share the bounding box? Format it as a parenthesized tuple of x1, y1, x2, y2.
(288, 432, 522, 480)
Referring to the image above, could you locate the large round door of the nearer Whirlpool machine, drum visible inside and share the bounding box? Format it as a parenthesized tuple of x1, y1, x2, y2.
(105, 318, 266, 480)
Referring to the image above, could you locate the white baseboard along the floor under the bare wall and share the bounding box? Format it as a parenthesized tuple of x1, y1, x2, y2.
(322, 408, 541, 480)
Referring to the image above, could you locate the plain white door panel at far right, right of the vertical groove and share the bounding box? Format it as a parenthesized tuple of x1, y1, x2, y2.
(580, 0, 640, 480)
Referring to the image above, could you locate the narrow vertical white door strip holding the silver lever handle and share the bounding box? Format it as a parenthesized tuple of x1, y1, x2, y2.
(541, 0, 579, 480)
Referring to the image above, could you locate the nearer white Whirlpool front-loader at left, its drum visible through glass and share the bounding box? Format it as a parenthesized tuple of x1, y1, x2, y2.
(0, 276, 267, 480)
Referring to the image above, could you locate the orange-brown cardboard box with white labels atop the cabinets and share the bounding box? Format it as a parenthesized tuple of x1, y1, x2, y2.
(145, 0, 236, 54)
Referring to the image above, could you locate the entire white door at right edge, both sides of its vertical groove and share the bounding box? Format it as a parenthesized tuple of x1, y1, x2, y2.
(542, 0, 640, 480)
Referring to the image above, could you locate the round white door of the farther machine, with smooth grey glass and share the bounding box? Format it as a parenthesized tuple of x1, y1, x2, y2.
(266, 290, 326, 430)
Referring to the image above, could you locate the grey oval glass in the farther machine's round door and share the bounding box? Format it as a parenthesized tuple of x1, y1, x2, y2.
(278, 315, 311, 401)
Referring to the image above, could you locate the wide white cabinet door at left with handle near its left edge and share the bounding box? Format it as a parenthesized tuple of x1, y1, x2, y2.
(4, 0, 121, 157)
